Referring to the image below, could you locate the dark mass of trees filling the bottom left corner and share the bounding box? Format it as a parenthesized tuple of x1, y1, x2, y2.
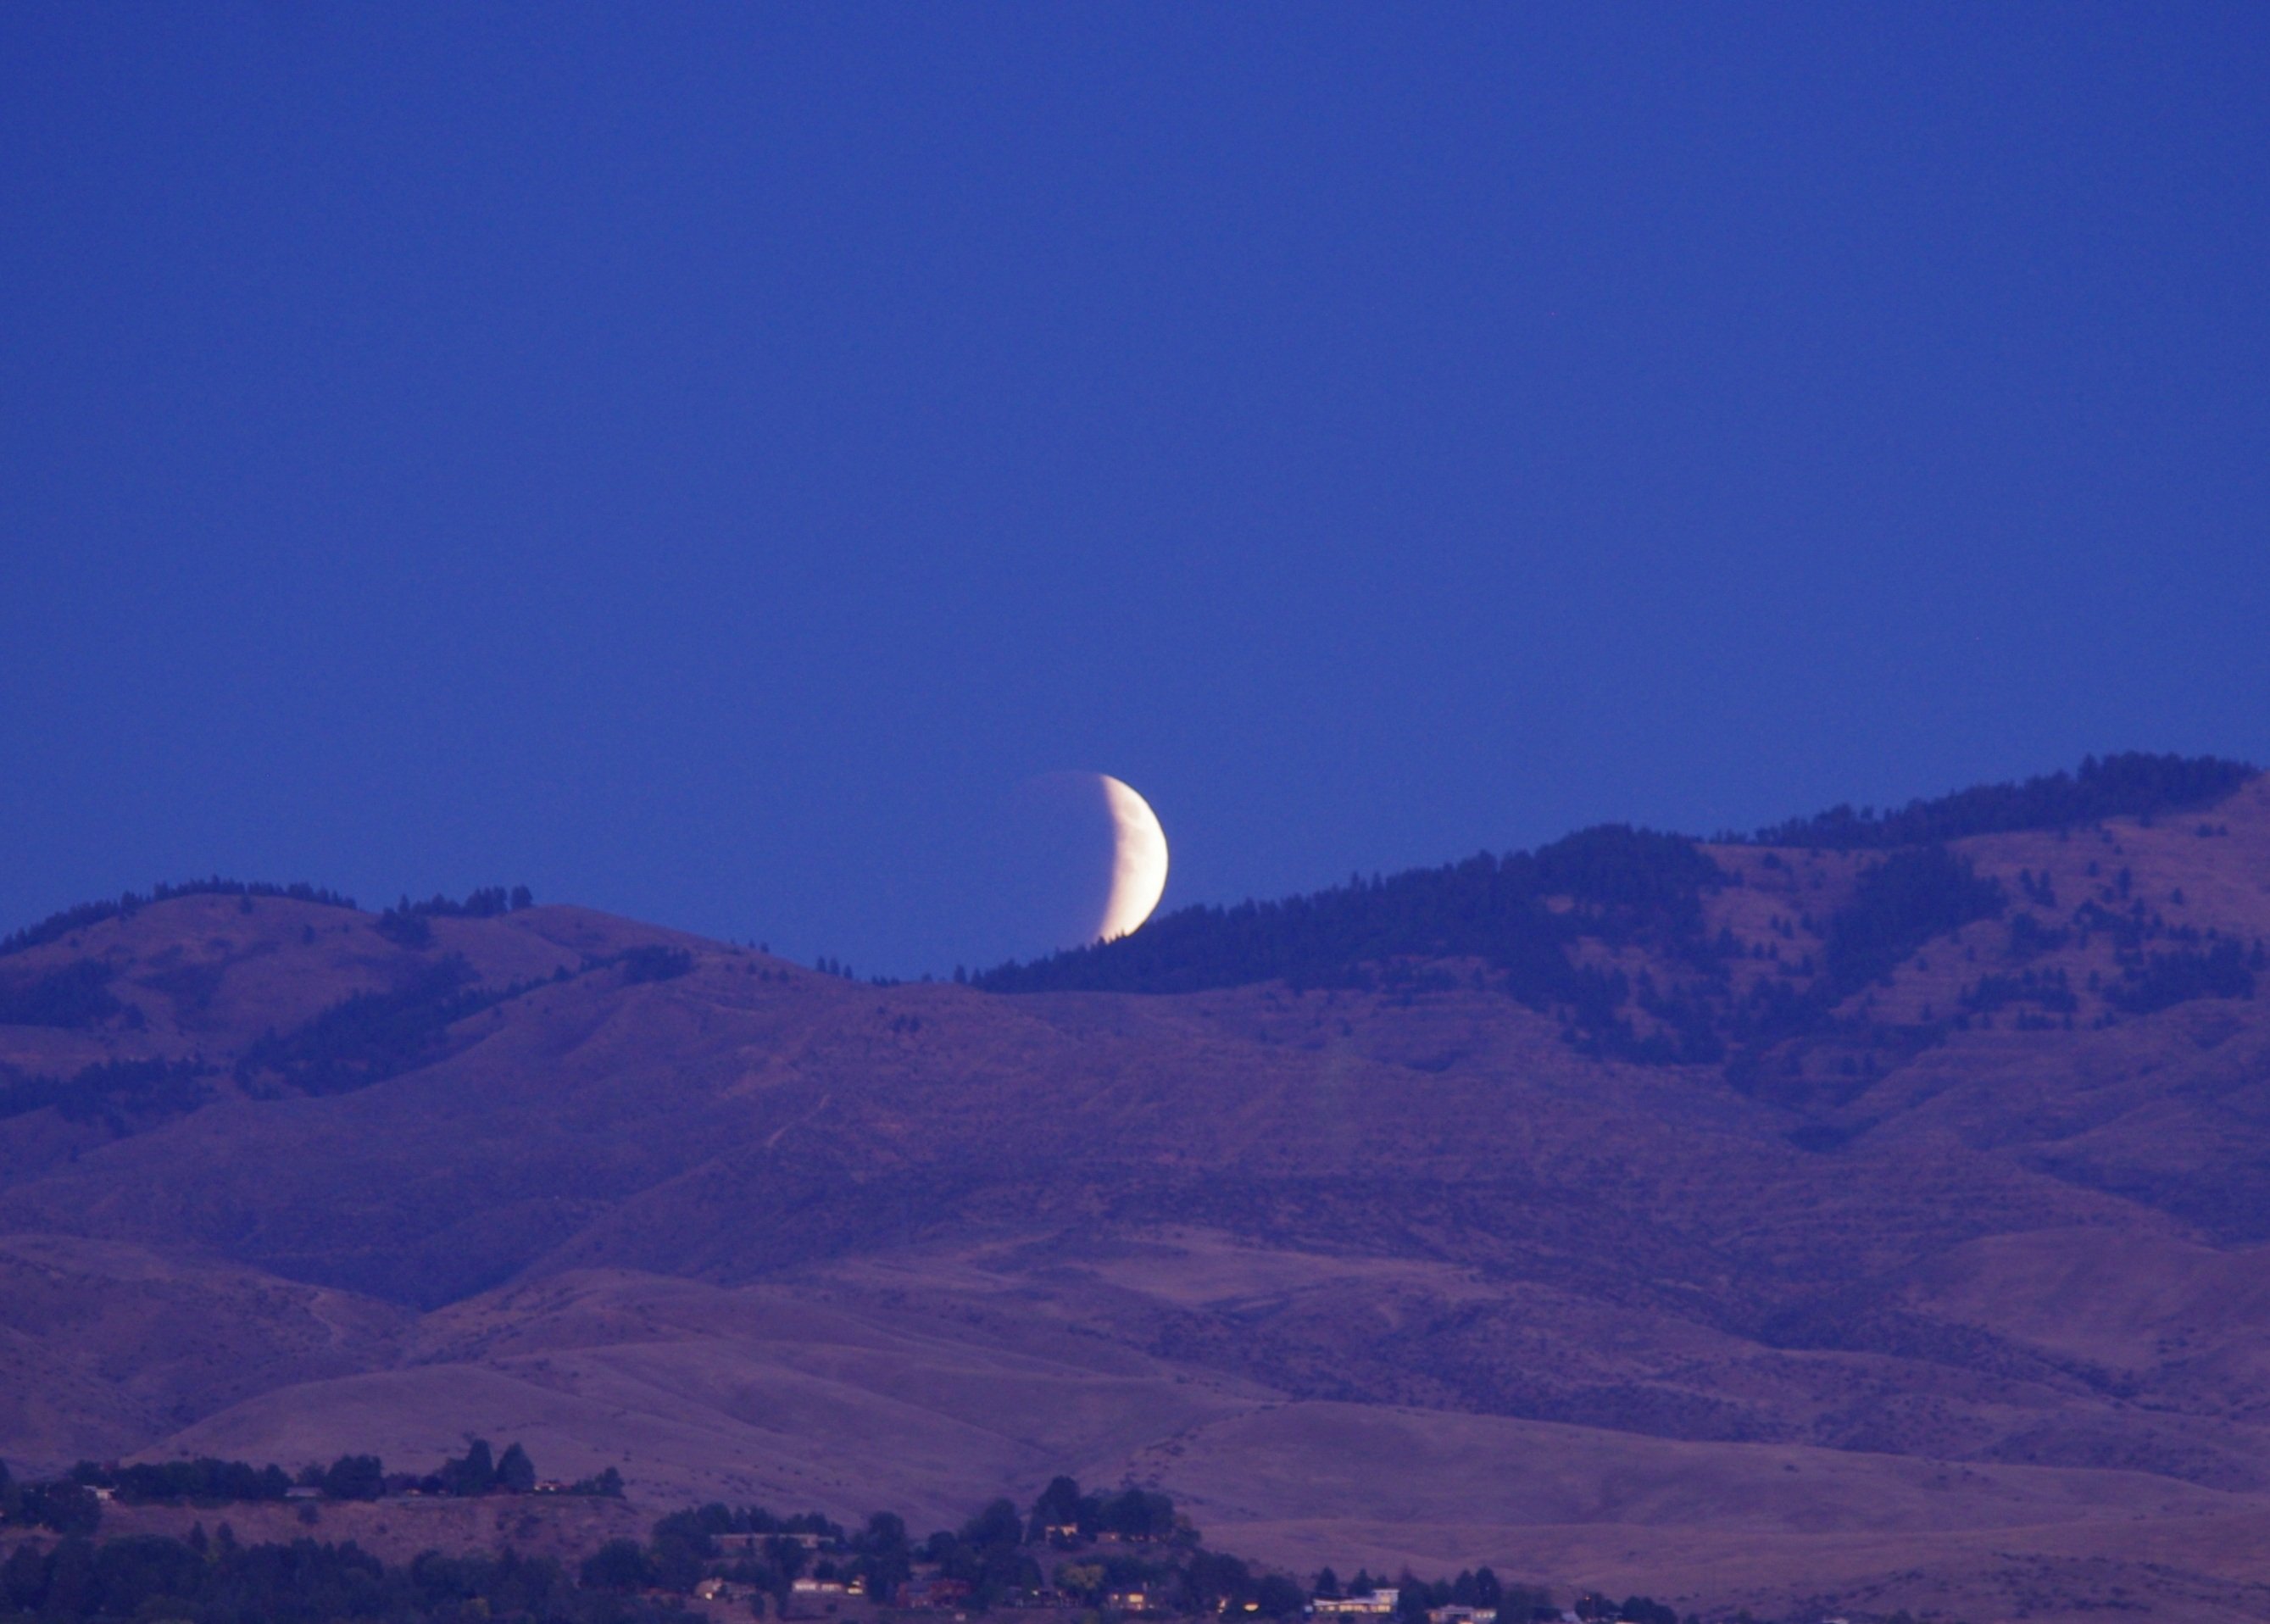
(0, 1524, 686, 1624)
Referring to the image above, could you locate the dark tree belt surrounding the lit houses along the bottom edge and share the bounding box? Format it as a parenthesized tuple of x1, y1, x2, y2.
(0, 1471, 1716, 1624)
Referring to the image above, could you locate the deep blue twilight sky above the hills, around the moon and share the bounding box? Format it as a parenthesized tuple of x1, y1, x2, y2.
(0, 3, 2270, 972)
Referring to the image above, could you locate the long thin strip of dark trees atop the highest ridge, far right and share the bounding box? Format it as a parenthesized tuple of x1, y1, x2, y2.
(1721, 752, 2256, 849)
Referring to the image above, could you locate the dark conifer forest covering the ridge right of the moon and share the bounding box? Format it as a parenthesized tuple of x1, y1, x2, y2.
(955, 754, 2263, 1083)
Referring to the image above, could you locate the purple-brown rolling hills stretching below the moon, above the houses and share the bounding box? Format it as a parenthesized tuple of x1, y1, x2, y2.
(0, 772, 2270, 1620)
